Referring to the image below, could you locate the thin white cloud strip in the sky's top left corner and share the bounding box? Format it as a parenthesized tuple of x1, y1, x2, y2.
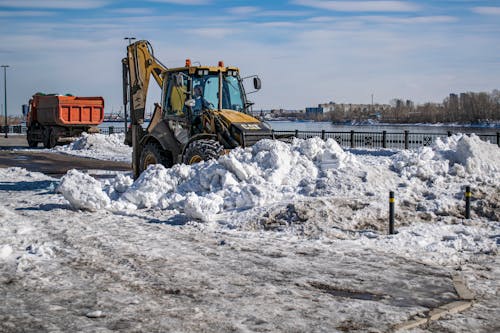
(0, 0, 109, 9)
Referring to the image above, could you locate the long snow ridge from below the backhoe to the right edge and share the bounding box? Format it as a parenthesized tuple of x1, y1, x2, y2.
(59, 136, 500, 229)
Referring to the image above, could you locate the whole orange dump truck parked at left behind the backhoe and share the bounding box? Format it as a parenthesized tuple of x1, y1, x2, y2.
(26, 94, 104, 148)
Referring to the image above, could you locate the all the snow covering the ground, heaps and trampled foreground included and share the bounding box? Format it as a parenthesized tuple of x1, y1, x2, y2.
(0, 135, 500, 332)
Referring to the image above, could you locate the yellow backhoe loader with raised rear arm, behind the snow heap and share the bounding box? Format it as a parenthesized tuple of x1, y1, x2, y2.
(122, 40, 274, 178)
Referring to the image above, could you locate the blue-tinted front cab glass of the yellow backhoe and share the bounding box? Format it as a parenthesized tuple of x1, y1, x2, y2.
(193, 74, 244, 111)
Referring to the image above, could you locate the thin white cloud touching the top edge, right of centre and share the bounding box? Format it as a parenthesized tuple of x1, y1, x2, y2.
(293, 0, 419, 12)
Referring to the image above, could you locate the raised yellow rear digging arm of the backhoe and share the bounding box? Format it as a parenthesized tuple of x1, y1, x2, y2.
(122, 40, 167, 125)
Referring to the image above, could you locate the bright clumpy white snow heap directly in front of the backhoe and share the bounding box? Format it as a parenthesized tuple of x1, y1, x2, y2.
(59, 138, 366, 220)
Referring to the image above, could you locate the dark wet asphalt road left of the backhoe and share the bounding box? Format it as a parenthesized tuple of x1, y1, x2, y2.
(0, 135, 131, 177)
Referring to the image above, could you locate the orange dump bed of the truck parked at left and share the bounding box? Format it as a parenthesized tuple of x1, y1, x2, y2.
(31, 95, 104, 127)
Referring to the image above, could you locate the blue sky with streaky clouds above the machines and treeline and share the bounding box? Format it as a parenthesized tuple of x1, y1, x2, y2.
(0, 0, 500, 115)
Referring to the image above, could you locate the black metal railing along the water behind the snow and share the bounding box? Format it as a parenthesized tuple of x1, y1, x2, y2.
(2, 125, 500, 149)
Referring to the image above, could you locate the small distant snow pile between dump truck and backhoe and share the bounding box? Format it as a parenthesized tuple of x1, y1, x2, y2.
(54, 133, 132, 162)
